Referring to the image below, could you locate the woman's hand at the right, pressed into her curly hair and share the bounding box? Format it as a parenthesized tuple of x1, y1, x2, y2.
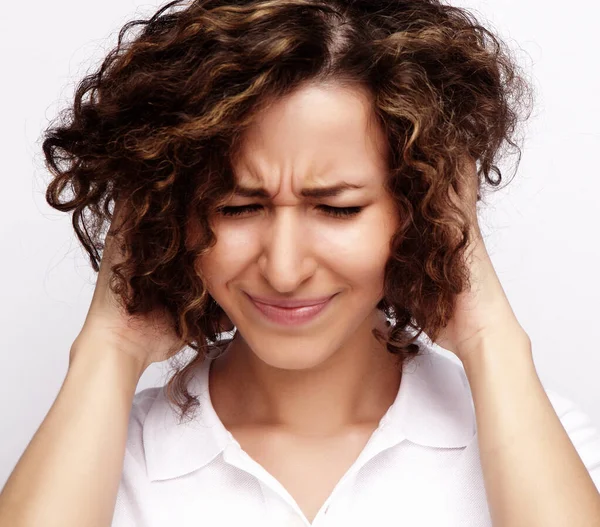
(435, 158, 526, 362)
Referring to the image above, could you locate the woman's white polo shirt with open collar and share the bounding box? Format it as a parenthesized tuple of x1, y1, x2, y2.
(112, 348, 600, 527)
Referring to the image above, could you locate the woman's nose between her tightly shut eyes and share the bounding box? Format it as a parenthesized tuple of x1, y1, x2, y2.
(258, 207, 316, 294)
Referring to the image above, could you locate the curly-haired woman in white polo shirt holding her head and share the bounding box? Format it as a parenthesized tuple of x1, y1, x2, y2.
(0, 0, 600, 527)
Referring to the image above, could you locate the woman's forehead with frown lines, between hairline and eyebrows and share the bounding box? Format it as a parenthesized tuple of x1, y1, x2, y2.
(234, 86, 387, 196)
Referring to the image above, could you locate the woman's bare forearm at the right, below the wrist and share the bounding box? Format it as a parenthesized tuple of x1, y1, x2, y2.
(463, 329, 600, 527)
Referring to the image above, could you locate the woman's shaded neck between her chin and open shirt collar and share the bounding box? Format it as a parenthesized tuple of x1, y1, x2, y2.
(210, 314, 401, 437)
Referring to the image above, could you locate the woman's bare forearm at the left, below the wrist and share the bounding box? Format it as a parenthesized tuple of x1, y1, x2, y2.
(0, 348, 141, 527)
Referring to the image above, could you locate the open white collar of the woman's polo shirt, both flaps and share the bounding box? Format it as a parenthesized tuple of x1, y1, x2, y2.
(142, 347, 476, 481)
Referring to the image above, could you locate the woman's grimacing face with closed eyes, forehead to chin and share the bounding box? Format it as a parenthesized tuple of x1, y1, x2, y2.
(199, 86, 397, 369)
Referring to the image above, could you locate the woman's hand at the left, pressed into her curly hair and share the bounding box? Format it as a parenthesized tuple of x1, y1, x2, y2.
(71, 197, 185, 371)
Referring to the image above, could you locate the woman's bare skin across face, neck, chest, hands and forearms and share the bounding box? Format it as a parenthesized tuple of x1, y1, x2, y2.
(0, 78, 600, 527)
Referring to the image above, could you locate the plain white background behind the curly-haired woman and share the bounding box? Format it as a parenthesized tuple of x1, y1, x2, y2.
(0, 0, 600, 485)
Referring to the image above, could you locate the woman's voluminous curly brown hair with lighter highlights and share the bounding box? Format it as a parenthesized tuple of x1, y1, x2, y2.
(43, 0, 532, 419)
